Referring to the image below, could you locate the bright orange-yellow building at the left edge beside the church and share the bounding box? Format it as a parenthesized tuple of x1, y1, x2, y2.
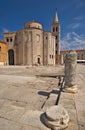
(0, 41, 7, 65)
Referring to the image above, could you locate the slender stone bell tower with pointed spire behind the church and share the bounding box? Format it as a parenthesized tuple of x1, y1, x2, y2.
(51, 13, 60, 63)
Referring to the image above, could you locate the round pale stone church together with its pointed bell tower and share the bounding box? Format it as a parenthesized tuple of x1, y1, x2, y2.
(4, 14, 60, 65)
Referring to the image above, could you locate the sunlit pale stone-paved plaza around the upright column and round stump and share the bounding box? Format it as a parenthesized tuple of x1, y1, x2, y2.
(0, 64, 85, 130)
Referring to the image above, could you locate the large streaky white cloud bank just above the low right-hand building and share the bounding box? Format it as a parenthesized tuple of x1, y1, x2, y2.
(61, 32, 85, 50)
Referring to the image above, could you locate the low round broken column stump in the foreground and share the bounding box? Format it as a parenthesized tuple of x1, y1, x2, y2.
(44, 106, 69, 130)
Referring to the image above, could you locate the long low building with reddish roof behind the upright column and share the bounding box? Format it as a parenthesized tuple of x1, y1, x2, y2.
(60, 49, 85, 61)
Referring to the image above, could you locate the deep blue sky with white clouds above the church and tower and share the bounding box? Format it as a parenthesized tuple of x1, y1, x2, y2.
(0, 0, 85, 50)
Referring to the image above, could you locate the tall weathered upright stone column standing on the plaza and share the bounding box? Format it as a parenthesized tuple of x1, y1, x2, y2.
(63, 51, 78, 93)
